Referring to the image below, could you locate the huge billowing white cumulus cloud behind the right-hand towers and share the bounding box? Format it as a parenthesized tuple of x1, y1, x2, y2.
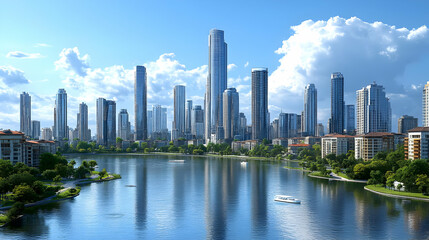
(269, 17, 429, 123)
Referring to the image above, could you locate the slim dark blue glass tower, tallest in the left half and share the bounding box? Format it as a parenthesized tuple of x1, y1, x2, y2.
(134, 66, 147, 140)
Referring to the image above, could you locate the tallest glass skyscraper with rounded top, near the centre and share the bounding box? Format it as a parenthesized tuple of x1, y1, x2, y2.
(205, 29, 228, 141)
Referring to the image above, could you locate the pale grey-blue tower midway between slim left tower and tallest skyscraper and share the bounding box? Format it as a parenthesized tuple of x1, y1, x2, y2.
(171, 85, 186, 140)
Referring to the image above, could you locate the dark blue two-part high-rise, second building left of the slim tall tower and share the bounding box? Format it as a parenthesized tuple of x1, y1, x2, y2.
(96, 98, 116, 146)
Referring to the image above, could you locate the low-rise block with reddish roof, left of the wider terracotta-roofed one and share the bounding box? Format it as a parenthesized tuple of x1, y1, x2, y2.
(321, 134, 355, 158)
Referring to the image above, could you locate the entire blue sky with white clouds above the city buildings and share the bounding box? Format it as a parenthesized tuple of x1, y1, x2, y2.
(0, 0, 429, 135)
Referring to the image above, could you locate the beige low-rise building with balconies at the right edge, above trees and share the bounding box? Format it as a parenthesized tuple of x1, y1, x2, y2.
(404, 127, 429, 160)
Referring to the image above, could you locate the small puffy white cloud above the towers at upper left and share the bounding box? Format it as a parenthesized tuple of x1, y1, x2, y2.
(55, 47, 89, 77)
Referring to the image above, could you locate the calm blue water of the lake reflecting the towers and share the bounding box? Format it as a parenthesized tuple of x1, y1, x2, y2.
(0, 155, 429, 240)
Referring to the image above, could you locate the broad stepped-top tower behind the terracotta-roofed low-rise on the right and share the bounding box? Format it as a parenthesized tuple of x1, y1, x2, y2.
(356, 83, 392, 134)
